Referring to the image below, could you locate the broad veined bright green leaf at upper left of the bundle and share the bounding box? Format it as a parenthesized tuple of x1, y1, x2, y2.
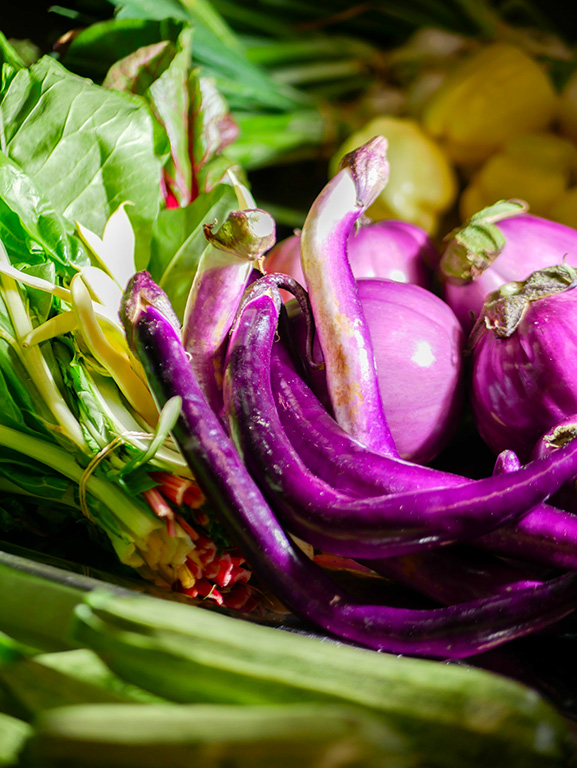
(1, 56, 161, 243)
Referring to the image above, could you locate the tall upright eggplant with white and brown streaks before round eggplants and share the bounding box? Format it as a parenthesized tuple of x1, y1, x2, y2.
(301, 136, 398, 456)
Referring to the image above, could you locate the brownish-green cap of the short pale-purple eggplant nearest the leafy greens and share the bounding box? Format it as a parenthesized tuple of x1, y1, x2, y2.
(203, 208, 276, 261)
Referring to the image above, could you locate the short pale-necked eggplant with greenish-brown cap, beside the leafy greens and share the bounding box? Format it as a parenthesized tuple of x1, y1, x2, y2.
(182, 208, 275, 411)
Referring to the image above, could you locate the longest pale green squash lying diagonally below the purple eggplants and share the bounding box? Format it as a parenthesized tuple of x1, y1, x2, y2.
(74, 593, 571, 768)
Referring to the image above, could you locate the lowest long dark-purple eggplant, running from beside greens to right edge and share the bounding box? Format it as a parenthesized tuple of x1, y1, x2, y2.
(120, 272, 577, 659)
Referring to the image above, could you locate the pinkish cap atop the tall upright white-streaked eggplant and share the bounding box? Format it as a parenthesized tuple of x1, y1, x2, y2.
(339, 136, 389, 210)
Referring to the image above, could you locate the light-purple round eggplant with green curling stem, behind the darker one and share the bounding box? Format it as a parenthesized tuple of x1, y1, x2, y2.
(440, 201, 577, 333)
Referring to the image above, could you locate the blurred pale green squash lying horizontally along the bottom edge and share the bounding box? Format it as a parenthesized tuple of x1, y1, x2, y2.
(15, 703, 408, 768)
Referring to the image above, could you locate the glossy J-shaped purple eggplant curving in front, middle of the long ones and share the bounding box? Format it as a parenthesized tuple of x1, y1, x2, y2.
(223, 275, 577, 558)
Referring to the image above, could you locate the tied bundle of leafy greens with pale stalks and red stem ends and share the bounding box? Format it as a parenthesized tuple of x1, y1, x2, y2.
(0, 31, 254, 608)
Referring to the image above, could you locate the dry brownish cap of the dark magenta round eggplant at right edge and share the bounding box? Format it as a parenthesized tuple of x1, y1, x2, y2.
(468, 264, 577, 350)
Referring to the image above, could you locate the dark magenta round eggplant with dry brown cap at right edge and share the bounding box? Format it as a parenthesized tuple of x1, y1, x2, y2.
(470, 265, 577, 461)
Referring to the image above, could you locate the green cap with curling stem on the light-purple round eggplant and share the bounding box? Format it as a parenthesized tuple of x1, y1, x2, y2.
(440, 200, 529, 285)
